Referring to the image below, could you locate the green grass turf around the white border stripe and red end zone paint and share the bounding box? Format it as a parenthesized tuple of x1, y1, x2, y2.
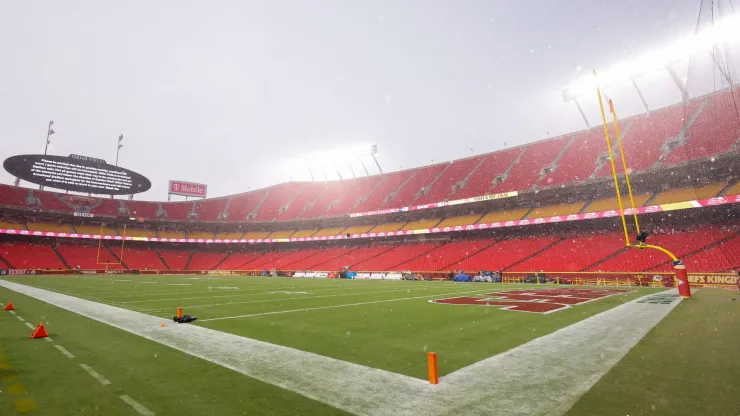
(0, 275, 740, 415)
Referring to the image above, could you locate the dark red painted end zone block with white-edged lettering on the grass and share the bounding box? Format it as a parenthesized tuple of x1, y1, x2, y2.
(429, 289, 629, 313)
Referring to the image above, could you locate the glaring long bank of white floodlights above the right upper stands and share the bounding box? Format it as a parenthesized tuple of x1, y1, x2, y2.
(563, 15, 740, 101)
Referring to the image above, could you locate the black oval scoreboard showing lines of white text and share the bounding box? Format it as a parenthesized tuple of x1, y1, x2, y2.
(3, 155, 152, 195)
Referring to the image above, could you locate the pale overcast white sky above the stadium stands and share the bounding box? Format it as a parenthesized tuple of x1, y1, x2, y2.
(0, 0, 736, 200)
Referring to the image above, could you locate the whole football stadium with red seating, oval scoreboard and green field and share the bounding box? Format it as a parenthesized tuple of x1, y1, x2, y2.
(0, 0, 740, 415)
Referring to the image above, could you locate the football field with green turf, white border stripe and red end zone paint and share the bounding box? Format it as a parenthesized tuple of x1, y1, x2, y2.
(0, 275, 740, 415)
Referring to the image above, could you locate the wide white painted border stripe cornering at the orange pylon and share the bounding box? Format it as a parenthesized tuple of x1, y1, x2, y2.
(0, 280, 680, 416)
